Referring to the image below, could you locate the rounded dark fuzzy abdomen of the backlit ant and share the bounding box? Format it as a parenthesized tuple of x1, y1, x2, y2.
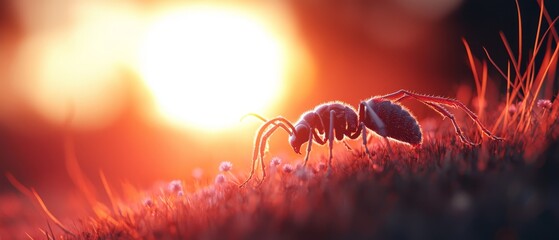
(365, 99, 422, 146)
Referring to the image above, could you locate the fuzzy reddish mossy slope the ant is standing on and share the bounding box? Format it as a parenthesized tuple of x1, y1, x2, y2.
(25, 107, 559, 239)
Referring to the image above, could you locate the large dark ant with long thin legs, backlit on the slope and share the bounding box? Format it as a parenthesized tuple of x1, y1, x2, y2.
(240, 89, 503, 187)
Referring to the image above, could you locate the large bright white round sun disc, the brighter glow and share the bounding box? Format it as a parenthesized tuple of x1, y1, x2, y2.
(139, 6, 285, 131)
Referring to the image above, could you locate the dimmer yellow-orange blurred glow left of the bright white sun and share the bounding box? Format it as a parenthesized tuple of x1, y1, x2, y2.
(15, 2, 141, 129)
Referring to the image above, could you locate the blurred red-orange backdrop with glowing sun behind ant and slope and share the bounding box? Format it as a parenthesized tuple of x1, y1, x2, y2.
(0, 0, 559, 236)
